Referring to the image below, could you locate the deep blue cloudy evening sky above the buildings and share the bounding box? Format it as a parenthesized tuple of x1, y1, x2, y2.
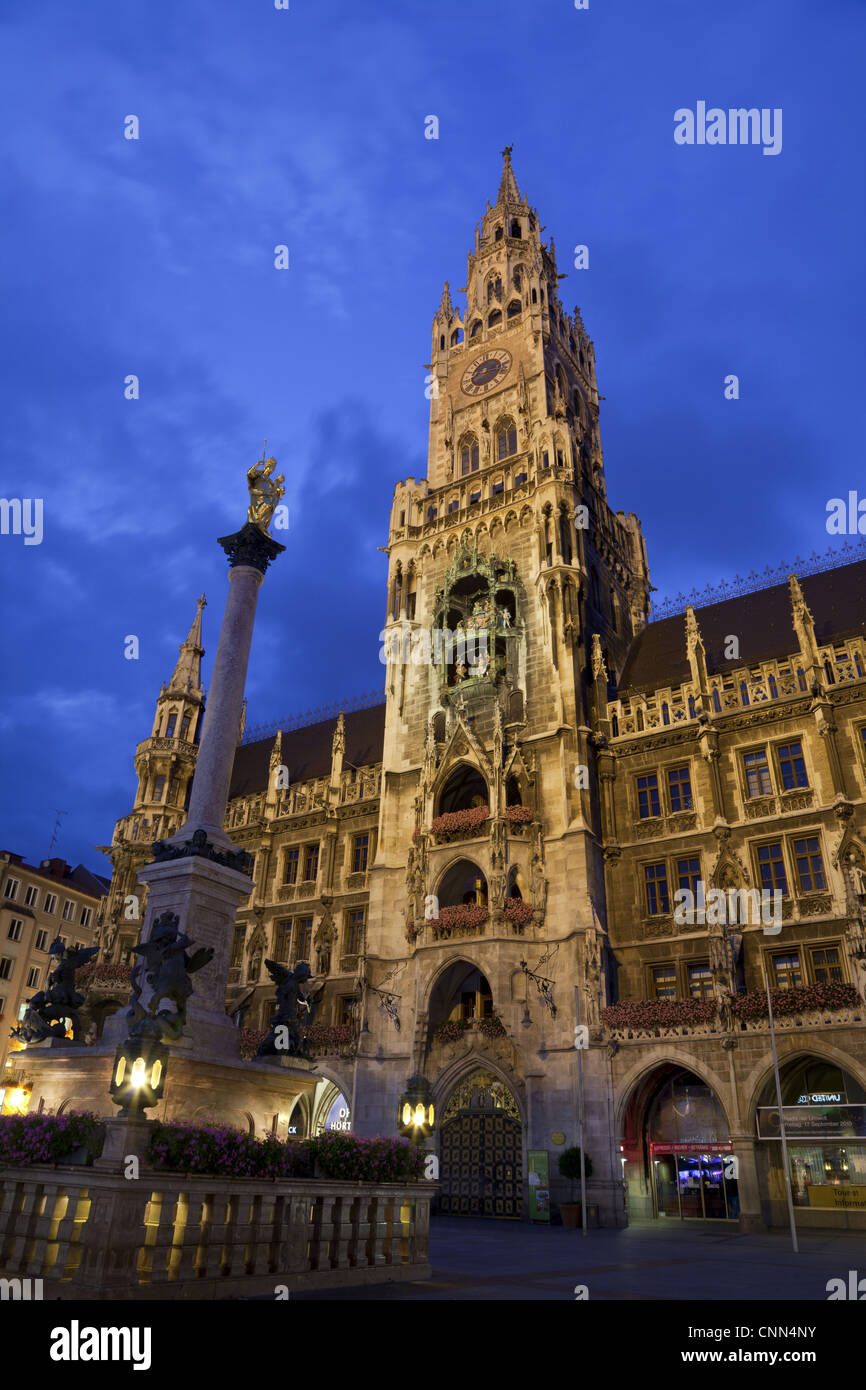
(0, 0, 866, 872)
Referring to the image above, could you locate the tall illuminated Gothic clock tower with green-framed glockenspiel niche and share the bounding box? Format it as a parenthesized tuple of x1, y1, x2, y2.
(359, 147, 649, 1220)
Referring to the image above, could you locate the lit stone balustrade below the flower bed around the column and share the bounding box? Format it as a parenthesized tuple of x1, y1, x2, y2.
(0, 1165, 436, 1300)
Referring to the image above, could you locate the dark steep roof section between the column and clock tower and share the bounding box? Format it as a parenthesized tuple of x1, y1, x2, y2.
(228, 703, 385, 801)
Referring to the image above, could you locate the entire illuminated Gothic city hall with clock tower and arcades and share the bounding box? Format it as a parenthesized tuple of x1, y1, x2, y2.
(54, 150, 866, 1230)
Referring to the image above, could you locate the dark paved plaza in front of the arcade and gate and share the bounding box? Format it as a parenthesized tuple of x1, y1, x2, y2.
(292, 1218, 866, 1302)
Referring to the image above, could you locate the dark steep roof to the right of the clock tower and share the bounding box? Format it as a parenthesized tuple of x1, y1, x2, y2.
(617, 560, 866, 695)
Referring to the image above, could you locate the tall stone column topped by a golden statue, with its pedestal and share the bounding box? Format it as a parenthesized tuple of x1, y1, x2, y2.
(104, 459, 285, 1059)
